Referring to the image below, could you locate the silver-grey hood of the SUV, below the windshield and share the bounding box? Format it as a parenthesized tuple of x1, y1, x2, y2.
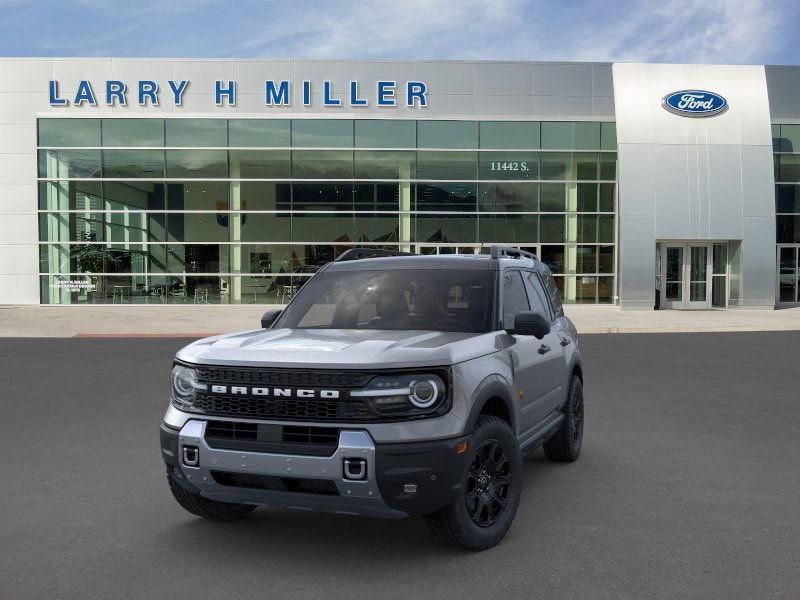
(177, 329, 500, 369)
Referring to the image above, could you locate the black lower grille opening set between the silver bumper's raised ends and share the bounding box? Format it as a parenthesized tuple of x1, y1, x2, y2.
(205, 421, 339, 456)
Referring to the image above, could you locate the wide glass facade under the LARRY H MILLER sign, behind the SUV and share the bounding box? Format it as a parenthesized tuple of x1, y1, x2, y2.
(38, 118, 620, 304)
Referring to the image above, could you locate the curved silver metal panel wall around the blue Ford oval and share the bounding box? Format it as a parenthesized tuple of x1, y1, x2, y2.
(613, 64, 775, 309)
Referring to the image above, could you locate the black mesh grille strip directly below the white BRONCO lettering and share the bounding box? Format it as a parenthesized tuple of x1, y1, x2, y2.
(194, 393, 372, 421)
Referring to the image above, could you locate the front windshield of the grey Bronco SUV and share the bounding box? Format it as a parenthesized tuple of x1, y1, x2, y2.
(275, 269, 494, 333)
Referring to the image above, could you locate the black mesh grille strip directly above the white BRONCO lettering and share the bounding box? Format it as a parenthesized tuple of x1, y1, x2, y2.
(197, 367, 375, 389)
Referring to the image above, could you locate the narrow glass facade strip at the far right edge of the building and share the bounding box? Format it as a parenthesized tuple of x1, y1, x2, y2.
(772, 125, 800, 304)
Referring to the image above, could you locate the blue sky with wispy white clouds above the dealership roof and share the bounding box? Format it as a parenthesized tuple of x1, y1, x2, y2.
(0, 0, 800, 64)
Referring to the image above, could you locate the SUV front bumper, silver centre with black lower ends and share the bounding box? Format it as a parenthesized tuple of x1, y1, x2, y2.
(161, 419, 467, 518)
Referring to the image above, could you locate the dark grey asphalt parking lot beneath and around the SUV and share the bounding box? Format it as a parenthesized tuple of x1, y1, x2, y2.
(0, 332, 800, 600)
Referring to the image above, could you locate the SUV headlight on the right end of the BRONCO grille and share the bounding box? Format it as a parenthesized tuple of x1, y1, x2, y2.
(350, 373, 448, 417)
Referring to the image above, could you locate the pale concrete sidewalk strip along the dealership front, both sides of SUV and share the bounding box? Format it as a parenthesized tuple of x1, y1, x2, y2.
(0, 305, 800, 337)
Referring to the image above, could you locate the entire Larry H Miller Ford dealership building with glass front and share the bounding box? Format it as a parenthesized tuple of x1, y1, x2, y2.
(0, 58, 800, 310)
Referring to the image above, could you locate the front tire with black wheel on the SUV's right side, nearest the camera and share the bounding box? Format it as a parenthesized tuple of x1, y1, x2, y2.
(424, 416, 522, 550)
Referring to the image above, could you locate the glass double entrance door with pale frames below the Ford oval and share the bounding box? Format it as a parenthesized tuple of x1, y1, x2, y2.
(661, 243, 712, 310)
